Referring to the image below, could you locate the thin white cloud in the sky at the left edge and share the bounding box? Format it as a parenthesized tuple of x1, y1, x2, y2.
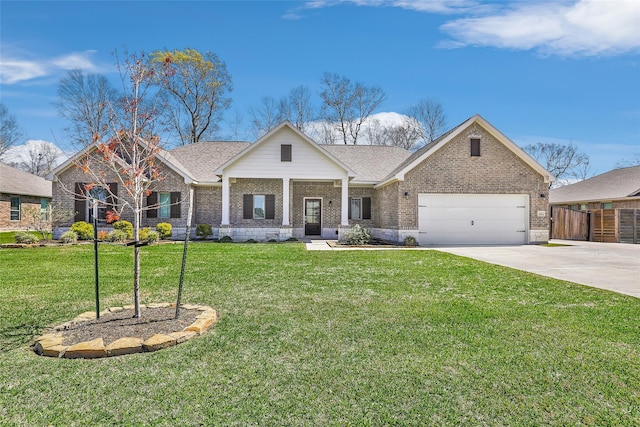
(0, 50, 98, 84)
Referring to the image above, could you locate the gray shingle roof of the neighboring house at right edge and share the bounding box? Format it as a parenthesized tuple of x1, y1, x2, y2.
(549, 166, 640, 204)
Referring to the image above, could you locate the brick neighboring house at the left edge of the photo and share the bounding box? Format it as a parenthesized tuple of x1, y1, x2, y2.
(0, 163, 51, 231)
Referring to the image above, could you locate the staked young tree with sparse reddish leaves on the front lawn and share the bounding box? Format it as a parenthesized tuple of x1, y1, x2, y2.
(69, 54, 164, 317)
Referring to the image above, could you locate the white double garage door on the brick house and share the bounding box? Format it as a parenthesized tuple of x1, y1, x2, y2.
(418, 194, 529, 245)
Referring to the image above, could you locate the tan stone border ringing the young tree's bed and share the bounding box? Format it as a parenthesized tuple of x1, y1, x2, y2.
(32, 303, 218, 359)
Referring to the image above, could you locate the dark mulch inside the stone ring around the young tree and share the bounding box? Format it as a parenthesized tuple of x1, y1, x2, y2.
(59, 307, 201, 345)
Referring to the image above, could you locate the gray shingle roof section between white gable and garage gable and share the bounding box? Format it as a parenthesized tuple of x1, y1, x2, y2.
(320, 145, 411, 183)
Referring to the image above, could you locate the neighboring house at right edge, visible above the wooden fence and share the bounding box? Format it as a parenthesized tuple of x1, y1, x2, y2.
(549, 166, 640, 211)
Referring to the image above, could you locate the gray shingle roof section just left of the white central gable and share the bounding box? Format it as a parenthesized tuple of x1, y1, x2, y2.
(169, 141, 250, 183)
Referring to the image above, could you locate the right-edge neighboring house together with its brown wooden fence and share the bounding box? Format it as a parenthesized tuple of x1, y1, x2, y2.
(549, 166, 640, 244)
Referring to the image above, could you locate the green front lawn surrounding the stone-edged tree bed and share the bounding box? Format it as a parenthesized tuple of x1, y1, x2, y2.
(0, 243, 640, 426)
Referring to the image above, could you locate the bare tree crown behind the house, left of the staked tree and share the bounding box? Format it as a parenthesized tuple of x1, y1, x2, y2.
(54, 70, 118, 147)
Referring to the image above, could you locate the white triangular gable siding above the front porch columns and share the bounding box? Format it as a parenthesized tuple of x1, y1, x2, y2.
(224, 127, 347, 180)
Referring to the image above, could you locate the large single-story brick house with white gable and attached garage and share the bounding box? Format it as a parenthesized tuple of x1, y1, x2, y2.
(54, 115, 555, 245)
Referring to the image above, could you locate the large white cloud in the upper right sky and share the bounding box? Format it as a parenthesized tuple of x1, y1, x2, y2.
(441, 0, 640, 56)
